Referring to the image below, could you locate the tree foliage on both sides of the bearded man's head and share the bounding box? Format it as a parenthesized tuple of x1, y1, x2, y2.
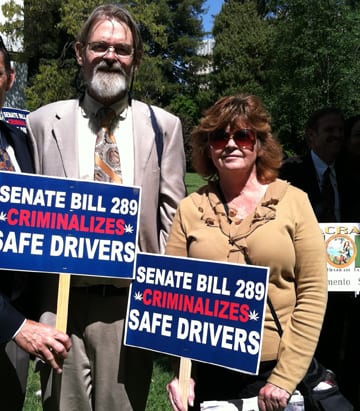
(1, 0, 205, 114)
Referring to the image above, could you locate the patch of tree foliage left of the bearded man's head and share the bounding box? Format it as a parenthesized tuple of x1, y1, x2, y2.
(24, 0, 82, 111)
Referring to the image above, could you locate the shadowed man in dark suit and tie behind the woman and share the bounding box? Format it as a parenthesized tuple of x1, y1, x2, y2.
(279, 107, 354, 400)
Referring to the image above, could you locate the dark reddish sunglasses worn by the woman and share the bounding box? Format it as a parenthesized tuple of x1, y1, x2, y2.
(209, 128, 256, 151)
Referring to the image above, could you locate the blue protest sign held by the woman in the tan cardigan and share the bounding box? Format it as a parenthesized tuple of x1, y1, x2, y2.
(125, 253, 268, 374)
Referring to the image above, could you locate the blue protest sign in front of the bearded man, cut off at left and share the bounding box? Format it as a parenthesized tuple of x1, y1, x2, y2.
(0, 171, 140, 278)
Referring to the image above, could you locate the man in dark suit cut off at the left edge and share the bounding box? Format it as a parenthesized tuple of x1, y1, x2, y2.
(0, 37, 71, 411)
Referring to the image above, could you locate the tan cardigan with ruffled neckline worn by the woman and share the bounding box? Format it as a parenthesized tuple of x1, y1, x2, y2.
(166, 179, 327, 393)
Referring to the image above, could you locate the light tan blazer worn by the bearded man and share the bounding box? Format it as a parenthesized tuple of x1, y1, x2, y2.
(27, 100, 185, 253)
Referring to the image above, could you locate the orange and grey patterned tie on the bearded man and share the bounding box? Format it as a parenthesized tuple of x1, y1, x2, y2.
(94, 107, 122, 184)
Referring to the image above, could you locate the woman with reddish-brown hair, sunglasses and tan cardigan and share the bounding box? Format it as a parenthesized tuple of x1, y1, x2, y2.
(166, 94, 331, 411)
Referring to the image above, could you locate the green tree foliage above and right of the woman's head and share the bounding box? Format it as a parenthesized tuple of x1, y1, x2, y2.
(210, 0, 360, 154)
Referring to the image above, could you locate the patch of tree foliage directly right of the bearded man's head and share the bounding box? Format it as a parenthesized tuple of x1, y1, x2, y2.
(134, 0, 204, 108)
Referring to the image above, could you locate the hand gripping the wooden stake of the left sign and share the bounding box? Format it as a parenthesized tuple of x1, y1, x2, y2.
(14, 320, 71, 374)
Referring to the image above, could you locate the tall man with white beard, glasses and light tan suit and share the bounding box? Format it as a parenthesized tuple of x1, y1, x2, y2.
(27, 4, 185, 411)
